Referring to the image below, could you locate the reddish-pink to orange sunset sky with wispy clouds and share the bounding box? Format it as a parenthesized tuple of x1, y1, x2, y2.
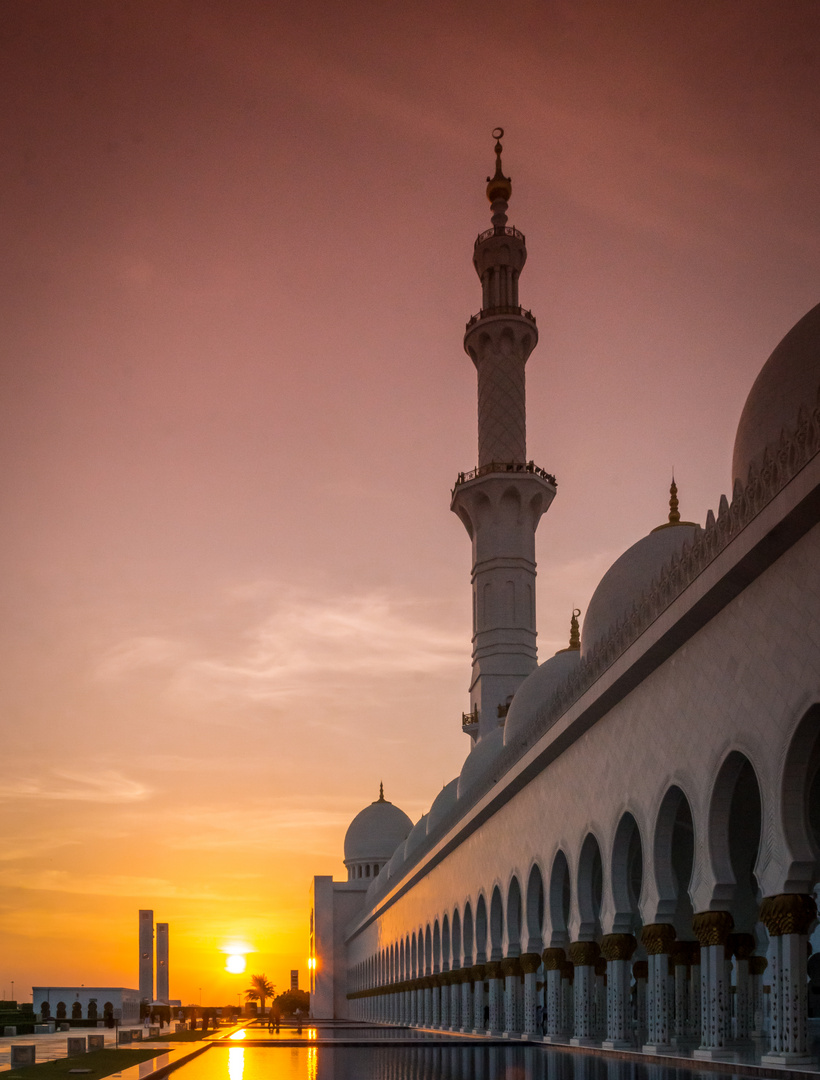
(0, 0, 820, 1004)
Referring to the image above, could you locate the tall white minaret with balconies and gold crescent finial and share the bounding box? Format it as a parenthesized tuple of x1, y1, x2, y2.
(451, 127, 555, 739)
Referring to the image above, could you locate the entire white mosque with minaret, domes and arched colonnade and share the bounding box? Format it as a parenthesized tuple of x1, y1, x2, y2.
(310, 131, 820, 1067)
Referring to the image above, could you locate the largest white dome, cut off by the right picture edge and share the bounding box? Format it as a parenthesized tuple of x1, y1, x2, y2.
(731, 303, 820, 484)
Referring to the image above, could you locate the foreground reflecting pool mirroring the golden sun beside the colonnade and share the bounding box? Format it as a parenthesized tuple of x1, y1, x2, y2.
(174, 1043, 738, 1080)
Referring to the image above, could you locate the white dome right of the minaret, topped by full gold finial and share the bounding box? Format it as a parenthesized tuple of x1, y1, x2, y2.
(583, 522, 700, 656)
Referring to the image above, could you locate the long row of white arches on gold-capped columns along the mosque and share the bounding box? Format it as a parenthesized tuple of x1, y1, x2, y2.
(348, 705, 820, 1064)
